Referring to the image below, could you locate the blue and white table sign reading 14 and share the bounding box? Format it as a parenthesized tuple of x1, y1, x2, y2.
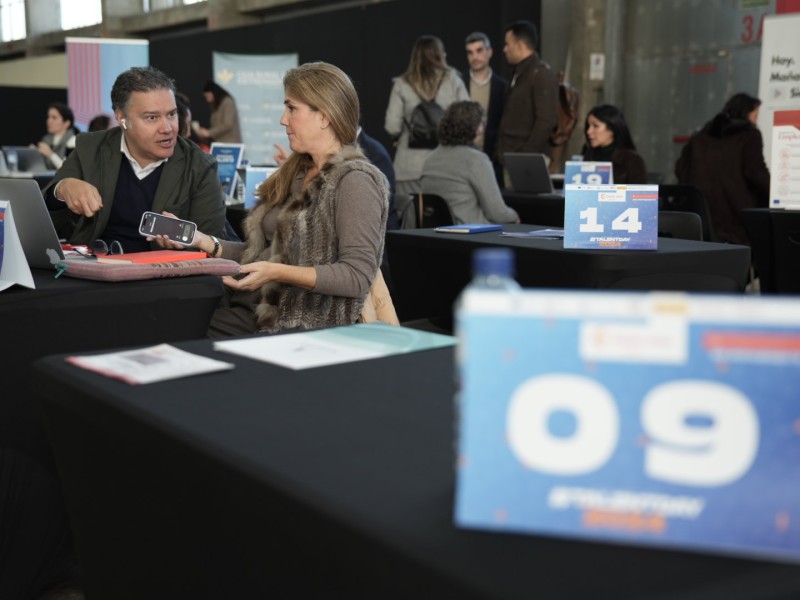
(564, 184, 658, 250)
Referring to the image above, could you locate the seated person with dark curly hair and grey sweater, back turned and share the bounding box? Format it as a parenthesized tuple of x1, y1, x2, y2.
(421, 100, 519, 224)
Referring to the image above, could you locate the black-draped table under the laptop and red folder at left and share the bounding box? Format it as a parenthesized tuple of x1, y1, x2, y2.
(0, 270, 223, 598)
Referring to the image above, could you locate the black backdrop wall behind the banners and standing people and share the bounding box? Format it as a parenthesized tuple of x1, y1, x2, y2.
(0, 0, 541, 161)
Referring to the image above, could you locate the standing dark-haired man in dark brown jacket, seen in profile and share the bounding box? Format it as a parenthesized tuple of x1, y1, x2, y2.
(496, 21, 558, 187)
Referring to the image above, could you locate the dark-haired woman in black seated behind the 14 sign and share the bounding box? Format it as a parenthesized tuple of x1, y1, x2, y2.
(581, 104, 647, 184)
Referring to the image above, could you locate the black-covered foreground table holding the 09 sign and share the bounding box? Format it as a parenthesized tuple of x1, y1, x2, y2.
(35, 340, 800, 600)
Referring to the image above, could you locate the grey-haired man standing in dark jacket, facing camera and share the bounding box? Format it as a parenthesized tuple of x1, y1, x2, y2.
(464, 31, 508, 186)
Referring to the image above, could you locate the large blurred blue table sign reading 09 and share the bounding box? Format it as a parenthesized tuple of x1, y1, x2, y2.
(455, 290, 800, 561)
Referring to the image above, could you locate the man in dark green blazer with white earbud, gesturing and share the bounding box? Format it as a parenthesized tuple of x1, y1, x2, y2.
(45, 67, 225, 252)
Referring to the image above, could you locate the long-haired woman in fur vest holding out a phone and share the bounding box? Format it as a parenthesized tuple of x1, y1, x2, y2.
(156, 62, 389, 338)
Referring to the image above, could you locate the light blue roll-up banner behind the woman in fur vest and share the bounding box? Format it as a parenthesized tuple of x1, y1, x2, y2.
(213, 52, 297, 165)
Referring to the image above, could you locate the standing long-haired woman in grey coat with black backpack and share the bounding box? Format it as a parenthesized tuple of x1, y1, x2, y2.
(384, 35, 469, 229)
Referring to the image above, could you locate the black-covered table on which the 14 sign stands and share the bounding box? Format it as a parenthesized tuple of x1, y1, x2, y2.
(386, 225, 750, 328)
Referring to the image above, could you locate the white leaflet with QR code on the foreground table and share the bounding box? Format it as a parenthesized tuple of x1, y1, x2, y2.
(67, 344, 234, 384)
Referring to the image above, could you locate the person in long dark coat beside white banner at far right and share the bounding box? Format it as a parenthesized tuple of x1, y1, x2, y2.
(675, 93, 770, 245)
